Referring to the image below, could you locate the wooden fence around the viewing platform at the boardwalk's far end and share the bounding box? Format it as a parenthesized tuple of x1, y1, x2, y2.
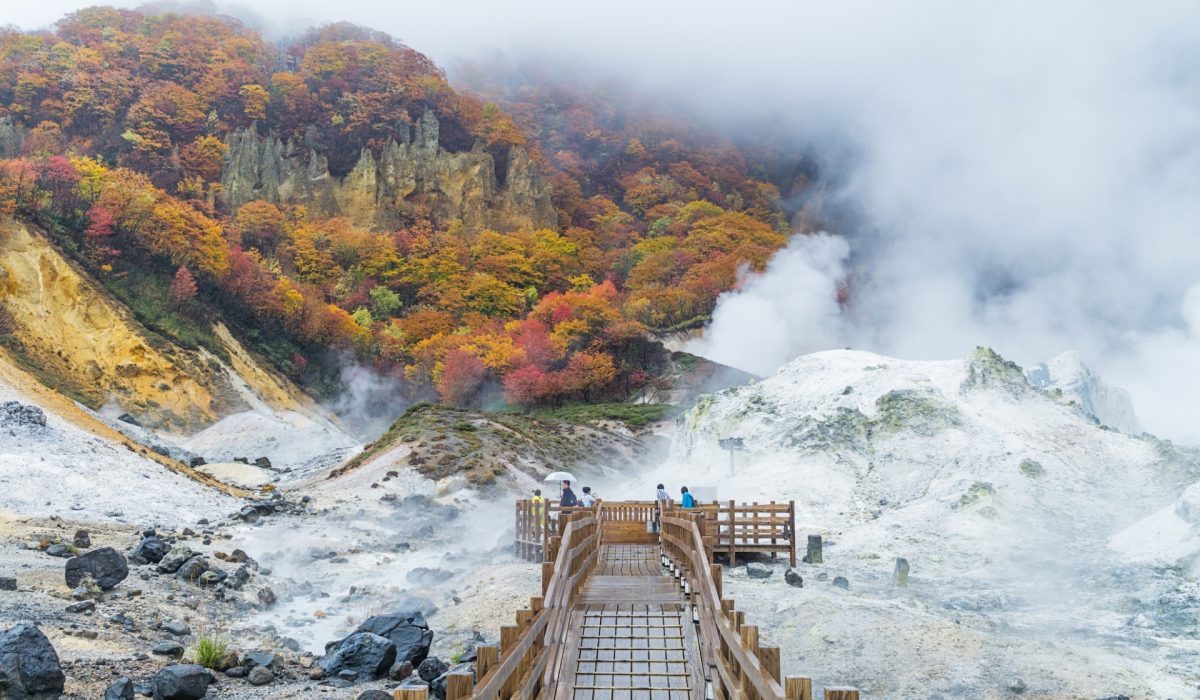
(514, 499, 796, 567)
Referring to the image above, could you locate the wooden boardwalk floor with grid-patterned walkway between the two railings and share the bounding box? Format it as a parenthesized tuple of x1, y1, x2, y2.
(556, 544, 704, 700)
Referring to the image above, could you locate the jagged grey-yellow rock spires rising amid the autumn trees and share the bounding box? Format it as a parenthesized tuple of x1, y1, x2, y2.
(222, 110, 558, 231)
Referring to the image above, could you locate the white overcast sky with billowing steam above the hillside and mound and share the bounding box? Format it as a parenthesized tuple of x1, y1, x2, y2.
(4, 0, 1200, 442)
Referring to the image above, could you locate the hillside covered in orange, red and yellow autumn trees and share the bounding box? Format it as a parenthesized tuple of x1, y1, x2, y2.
(0, 7, 806, 419)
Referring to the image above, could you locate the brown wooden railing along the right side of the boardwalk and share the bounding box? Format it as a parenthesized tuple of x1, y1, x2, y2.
(661, 510, 859, 700)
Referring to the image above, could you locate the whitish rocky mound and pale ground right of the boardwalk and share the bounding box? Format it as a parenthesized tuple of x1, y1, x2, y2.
(644, 348, 1200, 698)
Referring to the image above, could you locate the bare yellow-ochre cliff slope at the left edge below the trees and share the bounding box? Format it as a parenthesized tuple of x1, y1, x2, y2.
(0, 219, 311, 433)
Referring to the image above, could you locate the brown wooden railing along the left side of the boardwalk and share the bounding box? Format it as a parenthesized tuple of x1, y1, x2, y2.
(465, 511, 601, 700)
